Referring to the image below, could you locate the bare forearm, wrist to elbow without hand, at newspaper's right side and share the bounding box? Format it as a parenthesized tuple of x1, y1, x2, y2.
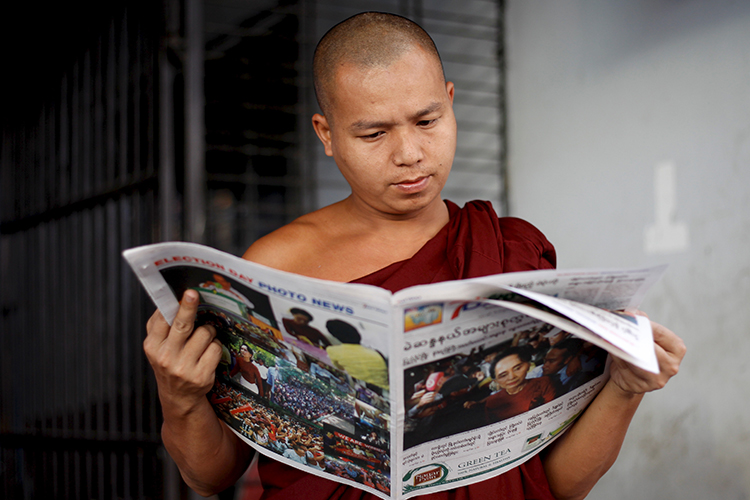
(544, 381, 643, 500)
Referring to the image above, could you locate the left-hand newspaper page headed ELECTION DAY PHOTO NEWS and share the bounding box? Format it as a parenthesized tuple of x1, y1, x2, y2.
(124, 243, 395, 498)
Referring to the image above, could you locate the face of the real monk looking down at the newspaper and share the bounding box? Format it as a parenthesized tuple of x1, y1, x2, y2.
(313, 47, 456, 215)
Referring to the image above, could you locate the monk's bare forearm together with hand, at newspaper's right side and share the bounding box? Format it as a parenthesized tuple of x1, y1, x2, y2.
(543, 322, 686, 500)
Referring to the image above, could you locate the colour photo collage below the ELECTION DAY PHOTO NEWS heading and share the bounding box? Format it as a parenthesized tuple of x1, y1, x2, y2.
(156, 266, 391, 494)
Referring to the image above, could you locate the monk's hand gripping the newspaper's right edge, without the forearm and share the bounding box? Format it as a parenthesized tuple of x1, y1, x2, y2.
(610, 312, 687, 395)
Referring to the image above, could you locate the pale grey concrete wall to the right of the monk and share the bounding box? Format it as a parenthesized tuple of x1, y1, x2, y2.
(506, 0, 750, 500)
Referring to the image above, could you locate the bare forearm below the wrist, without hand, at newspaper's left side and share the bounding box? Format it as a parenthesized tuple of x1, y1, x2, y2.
(162, 399, 251, 496)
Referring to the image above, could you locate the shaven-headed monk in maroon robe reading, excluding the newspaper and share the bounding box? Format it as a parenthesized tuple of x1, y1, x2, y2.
(144, 13, 685, 500)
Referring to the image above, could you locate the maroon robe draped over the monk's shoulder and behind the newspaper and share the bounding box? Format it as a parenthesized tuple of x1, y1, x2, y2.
(258, 201, 555, 500)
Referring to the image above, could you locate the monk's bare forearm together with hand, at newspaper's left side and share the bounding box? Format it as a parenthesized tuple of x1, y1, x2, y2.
(143, 290, 252, 496)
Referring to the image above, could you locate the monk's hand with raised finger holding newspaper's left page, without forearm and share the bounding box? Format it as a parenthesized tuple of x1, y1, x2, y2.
(143, 290, 221, 415)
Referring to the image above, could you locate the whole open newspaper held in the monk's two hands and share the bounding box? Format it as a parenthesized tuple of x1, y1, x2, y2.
(123, 243, 665, 499)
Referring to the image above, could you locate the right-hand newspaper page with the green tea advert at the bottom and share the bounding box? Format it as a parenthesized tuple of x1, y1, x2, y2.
(394, 268, 664, 498)
